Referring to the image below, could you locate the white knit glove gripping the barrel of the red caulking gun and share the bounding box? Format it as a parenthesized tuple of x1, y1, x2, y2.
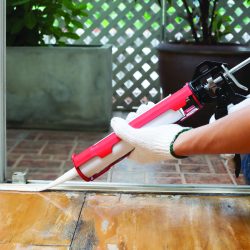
(111, 102, 190, 163)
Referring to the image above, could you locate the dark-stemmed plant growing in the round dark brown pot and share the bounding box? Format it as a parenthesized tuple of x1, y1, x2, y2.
(140, 0, 250, 45)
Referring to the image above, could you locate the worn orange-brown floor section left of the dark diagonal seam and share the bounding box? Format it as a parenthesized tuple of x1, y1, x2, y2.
(0, 192, 85, 246)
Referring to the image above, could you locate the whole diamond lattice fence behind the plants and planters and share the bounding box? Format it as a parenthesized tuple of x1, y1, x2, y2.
(70, 0, 250, 110)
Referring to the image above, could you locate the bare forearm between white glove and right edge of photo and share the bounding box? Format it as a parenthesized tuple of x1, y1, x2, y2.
(174, 106, 250, 155)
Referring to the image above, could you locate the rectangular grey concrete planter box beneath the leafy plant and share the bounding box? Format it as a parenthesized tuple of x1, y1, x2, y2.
(6, 45, 112, 130)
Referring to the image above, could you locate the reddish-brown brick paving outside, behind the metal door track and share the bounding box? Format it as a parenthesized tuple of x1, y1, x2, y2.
(7, 129, 245, 185)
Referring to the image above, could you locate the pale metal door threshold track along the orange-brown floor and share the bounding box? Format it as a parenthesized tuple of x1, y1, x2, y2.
(0, 180, 250, 195)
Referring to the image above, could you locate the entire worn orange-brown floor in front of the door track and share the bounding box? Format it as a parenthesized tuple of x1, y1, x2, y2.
(0, 192, 250, 250)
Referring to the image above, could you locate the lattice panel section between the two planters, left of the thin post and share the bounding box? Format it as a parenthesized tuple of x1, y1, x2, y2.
(74, 0, 161, 110)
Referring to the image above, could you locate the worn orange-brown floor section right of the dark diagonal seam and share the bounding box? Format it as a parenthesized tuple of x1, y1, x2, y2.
(72, 194, 250, 250)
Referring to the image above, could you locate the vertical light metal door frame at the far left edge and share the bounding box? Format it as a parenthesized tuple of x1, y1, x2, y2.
(0, 0, 6, 182)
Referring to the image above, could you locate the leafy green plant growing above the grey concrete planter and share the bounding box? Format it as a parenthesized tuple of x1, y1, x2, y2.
(6, 0, 87, 46)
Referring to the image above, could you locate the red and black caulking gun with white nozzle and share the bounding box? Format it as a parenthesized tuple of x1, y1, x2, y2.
(39, 57, 250, 191)
